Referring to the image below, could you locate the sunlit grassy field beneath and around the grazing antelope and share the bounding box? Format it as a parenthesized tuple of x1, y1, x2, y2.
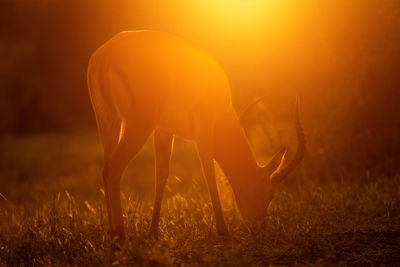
(0, 134, 400, 266)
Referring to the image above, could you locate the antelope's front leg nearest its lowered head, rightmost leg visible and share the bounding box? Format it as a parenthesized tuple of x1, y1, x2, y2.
(197, 124, 229, 237)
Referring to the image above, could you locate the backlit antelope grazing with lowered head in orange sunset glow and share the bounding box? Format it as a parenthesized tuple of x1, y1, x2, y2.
(87, 31, 305, 245)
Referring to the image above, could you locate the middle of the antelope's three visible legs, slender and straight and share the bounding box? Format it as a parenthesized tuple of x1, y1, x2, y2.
(149, 130, 173, 240)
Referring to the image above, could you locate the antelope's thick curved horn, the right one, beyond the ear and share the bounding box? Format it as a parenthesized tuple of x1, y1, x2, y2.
(271, 96, 306, 186)
